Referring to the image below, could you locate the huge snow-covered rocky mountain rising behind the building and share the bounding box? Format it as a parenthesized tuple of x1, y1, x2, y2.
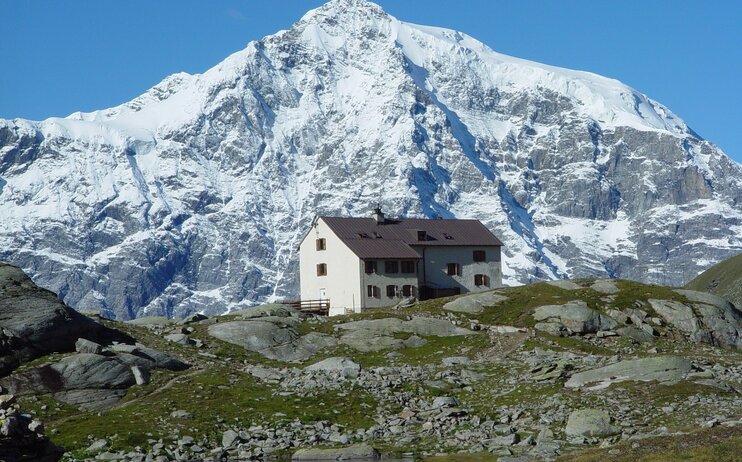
(0, 0, 742, 318)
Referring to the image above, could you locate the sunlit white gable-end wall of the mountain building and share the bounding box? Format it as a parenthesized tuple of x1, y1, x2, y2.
(299, 219, 366, 316)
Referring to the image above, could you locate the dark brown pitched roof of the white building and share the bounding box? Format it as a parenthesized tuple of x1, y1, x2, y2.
(320, 217, 502, 259)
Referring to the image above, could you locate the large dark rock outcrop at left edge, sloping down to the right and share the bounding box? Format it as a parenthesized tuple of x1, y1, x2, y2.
(0, 263, 133, 376)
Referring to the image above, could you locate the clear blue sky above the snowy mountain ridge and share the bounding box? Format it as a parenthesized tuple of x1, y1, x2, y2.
(0, 0, 742, 162)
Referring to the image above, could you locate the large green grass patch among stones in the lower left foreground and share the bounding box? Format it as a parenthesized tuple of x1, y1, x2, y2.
(47, 367, 377, 450)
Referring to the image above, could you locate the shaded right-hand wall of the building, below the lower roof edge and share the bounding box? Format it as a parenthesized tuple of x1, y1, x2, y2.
(413, 246, 502, 293)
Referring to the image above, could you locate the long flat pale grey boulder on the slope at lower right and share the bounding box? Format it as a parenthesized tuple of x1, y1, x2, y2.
(564, 356, 692, 389)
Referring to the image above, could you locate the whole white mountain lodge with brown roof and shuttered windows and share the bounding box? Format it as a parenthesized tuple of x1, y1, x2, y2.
(299, 208, 502, 316)
